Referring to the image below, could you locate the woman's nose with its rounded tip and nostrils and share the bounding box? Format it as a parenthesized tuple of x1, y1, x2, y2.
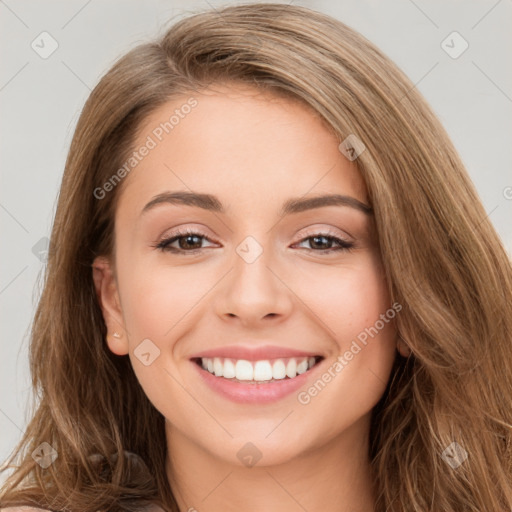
(215, 243, 293, 328)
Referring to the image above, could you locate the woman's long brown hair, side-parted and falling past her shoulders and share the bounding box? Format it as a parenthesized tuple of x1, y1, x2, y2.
(0, 3, 512, 512)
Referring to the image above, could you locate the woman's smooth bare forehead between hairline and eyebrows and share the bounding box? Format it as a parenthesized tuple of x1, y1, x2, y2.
(116, 84, 367, 218)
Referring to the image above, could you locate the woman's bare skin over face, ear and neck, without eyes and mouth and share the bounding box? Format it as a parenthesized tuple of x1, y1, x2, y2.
(93, 84, 410, 512)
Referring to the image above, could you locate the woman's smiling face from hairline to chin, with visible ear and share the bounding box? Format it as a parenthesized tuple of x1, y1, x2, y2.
(94, 85, 402, 465)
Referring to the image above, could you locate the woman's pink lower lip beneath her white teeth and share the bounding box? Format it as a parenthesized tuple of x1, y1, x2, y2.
(191, 361, 322, 404)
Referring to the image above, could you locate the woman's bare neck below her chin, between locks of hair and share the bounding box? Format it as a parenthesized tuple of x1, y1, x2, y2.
(166, 415, 375, 512)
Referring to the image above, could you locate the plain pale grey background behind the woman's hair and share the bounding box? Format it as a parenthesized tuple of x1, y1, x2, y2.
(0, 0, 512, 480)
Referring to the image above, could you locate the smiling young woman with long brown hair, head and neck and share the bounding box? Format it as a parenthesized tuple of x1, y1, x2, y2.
(0, 4, 512, 512)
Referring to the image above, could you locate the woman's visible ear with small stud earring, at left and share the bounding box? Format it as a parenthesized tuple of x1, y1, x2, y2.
(92, 256, 128, 356)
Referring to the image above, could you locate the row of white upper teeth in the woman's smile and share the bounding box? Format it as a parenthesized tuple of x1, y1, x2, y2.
(201, 357, 316, 382)
